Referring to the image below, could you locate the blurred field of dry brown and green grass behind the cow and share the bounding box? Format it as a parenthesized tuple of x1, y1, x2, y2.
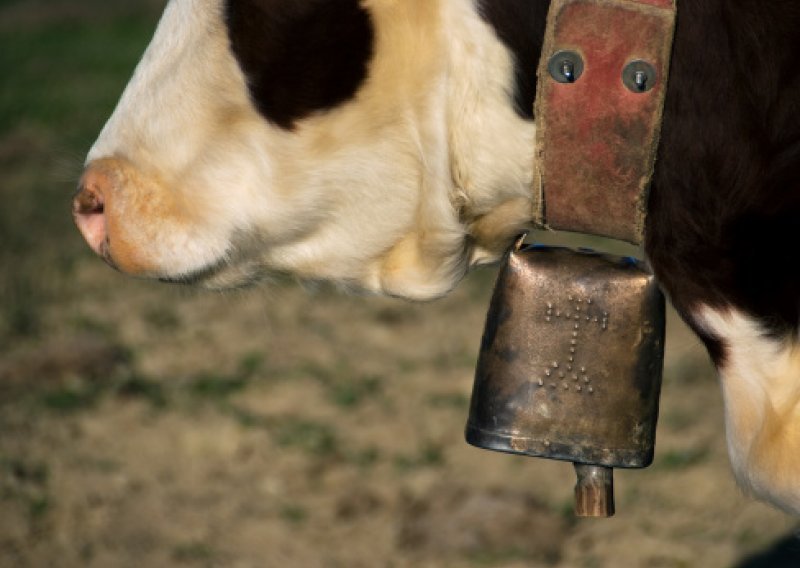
(0, 0, 800, 568)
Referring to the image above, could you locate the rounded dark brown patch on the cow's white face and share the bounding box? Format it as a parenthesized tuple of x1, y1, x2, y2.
(225, 0, 374, 129)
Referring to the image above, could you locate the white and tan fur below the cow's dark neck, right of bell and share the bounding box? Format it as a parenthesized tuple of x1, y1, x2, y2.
(695, 307, 800, 515)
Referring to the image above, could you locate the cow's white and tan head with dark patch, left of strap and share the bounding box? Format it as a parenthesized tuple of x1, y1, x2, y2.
(74, 0, 533, 299)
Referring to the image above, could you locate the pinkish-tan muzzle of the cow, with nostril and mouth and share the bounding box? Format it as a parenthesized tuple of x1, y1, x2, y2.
(72, 157, 244, 288)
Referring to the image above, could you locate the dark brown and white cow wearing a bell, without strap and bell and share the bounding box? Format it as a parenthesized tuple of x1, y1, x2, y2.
(73, 0, 800, 515)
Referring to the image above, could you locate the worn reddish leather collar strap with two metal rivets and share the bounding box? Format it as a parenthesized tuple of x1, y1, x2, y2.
(534, 0, 676, 244)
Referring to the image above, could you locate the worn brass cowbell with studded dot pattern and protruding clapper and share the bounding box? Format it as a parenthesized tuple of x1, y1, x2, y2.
(466, 239, 665, 517)
